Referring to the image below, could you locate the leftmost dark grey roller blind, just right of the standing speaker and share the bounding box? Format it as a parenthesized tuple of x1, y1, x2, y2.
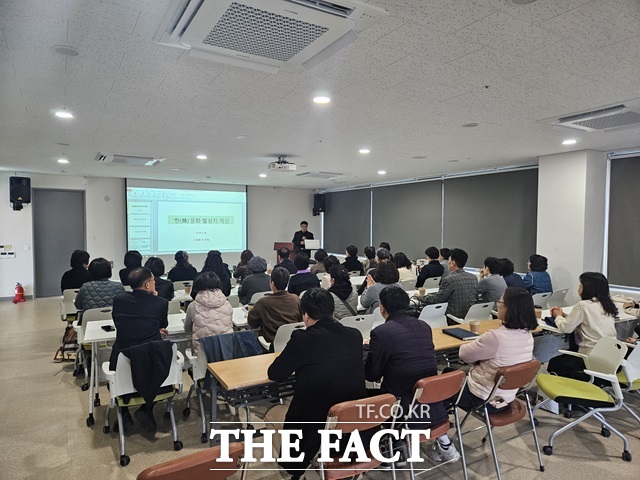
(324, 189, 371, 254)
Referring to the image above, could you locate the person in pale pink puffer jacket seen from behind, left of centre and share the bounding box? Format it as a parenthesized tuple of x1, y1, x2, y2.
(184, 272, 233, 355)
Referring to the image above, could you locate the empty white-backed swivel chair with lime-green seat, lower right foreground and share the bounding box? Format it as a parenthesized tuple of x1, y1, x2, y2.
(534, 337, 631, 462)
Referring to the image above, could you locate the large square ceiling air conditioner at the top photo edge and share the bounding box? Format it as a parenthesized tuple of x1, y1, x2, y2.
(154, 0, 388, 73)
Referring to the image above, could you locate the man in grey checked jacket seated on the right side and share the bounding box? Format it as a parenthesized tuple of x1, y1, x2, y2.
(418, 248, 478, 318)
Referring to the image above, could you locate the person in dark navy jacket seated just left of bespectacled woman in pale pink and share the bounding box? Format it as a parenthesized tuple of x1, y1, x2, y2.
(364, 287, 455, 452)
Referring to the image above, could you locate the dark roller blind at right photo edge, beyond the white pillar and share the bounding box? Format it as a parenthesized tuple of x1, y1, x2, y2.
(607, 157, 640, 287)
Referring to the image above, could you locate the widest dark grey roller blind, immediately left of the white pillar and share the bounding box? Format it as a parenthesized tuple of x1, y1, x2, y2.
(444, 169, 538, 272)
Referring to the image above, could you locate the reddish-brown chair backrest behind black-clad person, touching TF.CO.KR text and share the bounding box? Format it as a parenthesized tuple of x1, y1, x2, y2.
(325, 393, 397, 433)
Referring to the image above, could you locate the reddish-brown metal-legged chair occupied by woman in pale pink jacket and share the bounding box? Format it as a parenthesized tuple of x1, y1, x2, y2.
(460, 360, 544, 480)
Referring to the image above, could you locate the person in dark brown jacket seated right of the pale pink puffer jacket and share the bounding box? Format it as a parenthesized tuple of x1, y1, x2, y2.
(247, 267, 302, 343)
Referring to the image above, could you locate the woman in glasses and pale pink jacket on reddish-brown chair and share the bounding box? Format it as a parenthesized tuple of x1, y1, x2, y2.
(428, 288, 538, 462)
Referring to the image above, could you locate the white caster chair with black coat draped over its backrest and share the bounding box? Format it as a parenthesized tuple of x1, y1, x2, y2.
(102, 344, 184, 467)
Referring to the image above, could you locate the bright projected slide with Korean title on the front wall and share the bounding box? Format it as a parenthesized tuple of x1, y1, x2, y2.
(127, 187, 247, 255)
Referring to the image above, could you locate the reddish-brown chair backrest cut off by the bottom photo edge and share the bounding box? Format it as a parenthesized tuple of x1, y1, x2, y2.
(137, 442, 244, 480)
